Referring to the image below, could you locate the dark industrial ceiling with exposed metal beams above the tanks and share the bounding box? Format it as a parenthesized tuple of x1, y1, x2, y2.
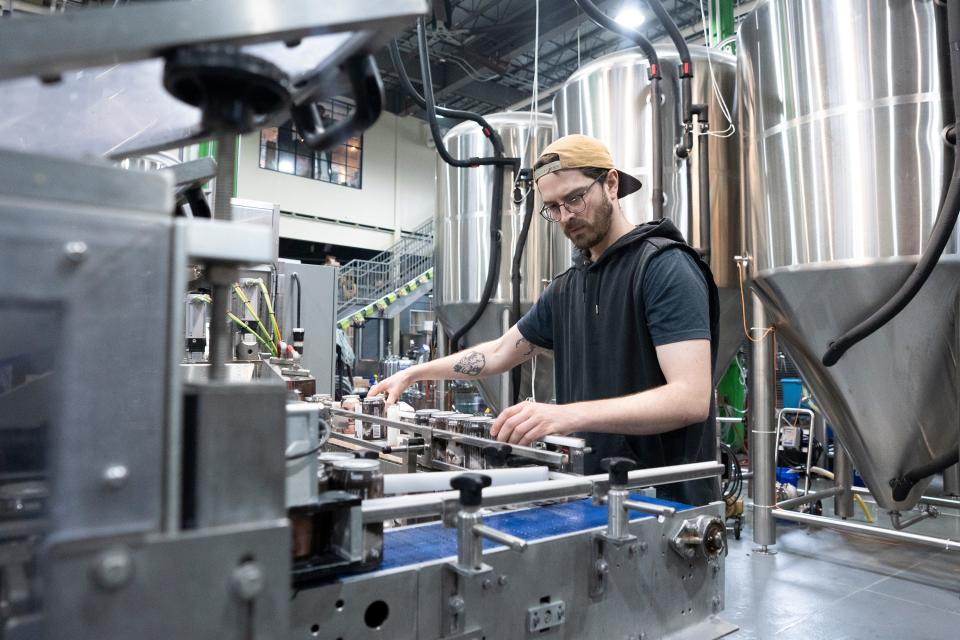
(378, 0, 756, 113)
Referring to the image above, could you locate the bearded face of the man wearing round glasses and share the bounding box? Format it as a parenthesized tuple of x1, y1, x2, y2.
(537, 169, 617, 251)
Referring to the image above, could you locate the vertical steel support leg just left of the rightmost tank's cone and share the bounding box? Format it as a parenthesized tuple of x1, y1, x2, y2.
(750, 293, 777, 551)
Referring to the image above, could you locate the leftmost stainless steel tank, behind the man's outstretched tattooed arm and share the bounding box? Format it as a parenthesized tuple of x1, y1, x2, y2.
(434, 112, 571, 410)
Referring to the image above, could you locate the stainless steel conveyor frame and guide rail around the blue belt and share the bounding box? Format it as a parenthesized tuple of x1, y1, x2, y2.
(291, 463, 736, 640)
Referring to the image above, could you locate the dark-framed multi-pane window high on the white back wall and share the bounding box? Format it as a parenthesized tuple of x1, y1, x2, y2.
(260, 100, 363, 189)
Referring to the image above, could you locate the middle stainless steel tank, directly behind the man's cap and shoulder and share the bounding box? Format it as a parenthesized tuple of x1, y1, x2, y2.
(553, 46, 743, 376)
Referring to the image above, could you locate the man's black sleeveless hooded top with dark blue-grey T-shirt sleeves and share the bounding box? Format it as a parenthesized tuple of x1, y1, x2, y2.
(517, 219, 719, 505)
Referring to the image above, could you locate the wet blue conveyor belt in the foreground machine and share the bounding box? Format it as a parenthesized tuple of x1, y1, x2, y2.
(380, 495, 693, 570)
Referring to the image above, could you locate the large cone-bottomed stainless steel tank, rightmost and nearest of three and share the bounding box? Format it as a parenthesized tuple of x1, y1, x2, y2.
(737, 0, 960, 509)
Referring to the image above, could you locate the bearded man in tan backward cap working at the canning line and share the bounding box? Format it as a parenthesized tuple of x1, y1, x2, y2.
(371, 135, 719, 505)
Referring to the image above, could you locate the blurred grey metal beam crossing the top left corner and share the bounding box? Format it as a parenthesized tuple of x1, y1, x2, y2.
(0, 0, 427, 79)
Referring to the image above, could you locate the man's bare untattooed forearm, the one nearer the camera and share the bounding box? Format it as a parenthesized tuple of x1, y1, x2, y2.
(569, 384, 710, 435)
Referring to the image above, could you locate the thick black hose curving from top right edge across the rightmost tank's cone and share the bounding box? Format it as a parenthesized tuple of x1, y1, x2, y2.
(822, 2, 960, 367)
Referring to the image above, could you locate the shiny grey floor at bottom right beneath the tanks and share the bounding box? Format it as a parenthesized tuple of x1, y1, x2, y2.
(722, 488, 960, 640)
